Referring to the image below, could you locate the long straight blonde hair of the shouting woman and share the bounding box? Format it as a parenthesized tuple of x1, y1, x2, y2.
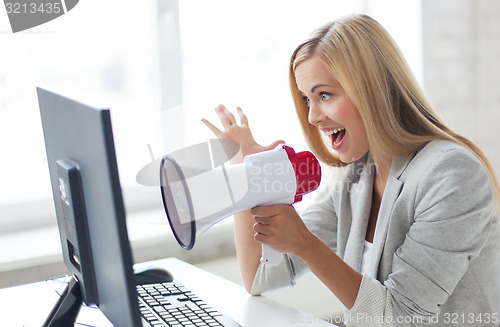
(289, 15, 500, 203)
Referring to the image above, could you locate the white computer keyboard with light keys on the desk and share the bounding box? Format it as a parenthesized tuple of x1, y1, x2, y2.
(137, 282, 241, 327)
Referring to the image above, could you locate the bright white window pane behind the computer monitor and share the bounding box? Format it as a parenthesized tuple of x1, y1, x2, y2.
(0, 0, 158, 231)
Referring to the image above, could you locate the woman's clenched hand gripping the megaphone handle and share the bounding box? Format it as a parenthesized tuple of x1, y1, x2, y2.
(250, 204, 315, 257)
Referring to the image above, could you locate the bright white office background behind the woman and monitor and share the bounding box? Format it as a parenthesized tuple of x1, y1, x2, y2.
(0, 0, 500, 317)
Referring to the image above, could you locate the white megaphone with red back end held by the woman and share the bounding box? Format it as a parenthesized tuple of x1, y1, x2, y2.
(160, 144, 321, 265)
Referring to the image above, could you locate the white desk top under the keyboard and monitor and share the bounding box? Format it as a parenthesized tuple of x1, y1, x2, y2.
(0, 258, 333, 327)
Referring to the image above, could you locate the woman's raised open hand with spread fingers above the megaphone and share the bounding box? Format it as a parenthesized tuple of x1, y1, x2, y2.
(201, 105, 284, 163)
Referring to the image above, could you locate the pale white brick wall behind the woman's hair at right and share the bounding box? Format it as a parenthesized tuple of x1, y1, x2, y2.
(422, 0, 500, 174)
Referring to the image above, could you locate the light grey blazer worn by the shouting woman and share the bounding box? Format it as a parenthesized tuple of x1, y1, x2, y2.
(252, 140, 500, 326)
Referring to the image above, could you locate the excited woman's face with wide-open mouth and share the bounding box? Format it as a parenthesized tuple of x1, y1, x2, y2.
(295, 57, 369, 163)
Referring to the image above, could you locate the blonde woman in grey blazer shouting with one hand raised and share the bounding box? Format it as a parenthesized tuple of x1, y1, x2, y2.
(203, 15, 500, 326)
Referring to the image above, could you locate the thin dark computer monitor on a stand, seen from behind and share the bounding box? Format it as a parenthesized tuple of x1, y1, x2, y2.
(37, 88, 142, 326)
